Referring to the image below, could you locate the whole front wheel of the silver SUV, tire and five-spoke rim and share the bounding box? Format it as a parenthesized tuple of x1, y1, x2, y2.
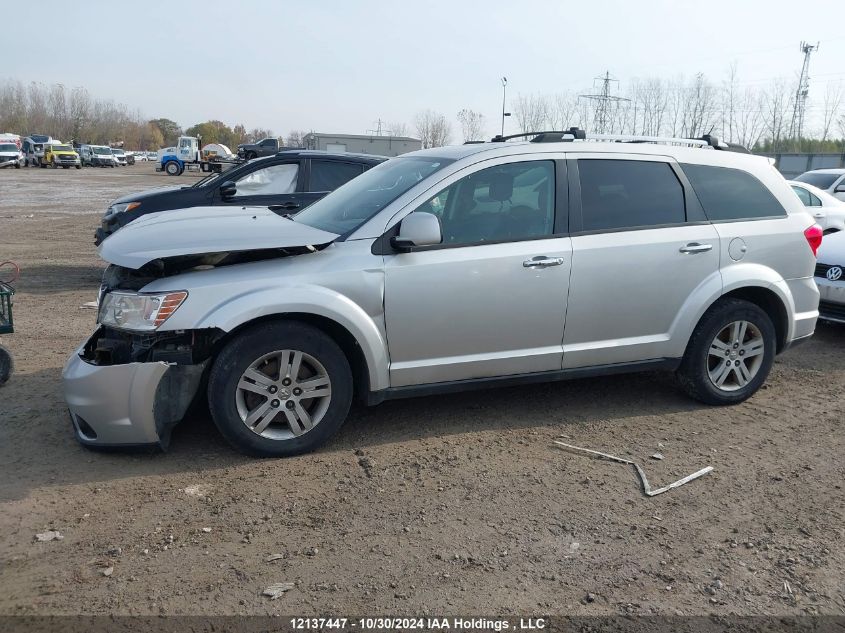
(208, 321, 352, 457)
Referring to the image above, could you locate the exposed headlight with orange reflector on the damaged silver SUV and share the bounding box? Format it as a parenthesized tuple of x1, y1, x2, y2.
(97, 291, 188, 332)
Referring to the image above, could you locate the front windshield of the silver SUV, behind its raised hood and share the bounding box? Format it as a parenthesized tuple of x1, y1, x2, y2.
(293, 156, 453, 235)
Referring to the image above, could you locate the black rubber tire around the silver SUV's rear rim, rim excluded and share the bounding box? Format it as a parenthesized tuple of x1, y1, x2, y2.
(676, 299, 777, 405)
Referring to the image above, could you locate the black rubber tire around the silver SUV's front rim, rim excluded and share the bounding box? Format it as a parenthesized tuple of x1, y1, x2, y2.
(208, 321, 353, 457)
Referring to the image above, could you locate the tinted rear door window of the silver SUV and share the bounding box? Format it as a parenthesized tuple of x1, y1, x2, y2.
(578, 159, 686, 231)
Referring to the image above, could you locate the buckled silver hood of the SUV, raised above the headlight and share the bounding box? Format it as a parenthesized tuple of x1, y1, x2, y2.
(98, 207, 338, 269)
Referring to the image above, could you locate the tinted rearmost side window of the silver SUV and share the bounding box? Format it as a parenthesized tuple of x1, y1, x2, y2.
(681, 164, 786, 222)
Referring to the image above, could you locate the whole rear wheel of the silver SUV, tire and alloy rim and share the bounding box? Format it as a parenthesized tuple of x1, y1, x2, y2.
(677, 299, 776, 405)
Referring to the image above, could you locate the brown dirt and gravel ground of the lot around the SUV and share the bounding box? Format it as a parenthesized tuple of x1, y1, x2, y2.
(0, 164, 845, 615)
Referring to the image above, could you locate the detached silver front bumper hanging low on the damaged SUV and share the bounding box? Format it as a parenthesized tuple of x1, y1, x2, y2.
(62, 328, 214, 449)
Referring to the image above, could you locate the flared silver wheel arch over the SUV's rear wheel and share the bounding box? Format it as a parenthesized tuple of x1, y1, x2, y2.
(668, 262, 795, 358)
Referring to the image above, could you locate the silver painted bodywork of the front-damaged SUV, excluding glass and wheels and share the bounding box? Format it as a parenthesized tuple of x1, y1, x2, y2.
(65, 143, 818, 441)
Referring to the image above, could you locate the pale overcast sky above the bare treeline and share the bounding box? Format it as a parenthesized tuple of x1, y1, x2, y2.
(6, 0, 845, 140)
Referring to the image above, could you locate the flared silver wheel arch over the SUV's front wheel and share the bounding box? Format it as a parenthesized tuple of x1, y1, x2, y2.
(194, 285, 390, 391)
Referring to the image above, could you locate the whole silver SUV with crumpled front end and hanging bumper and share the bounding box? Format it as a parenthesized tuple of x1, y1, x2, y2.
(64, 129, 822, 455)
